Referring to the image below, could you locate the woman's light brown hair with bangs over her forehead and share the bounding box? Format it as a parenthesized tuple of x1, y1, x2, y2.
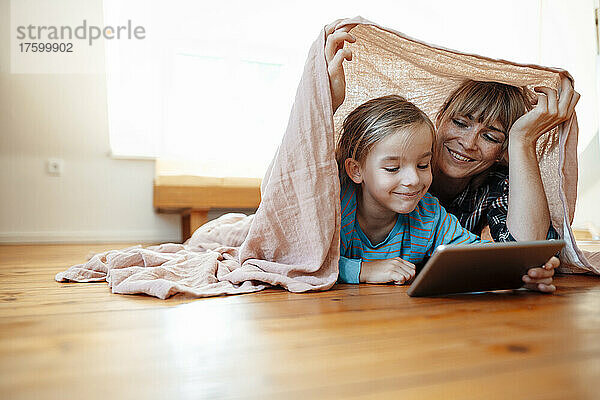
(436, 79, 533, 150)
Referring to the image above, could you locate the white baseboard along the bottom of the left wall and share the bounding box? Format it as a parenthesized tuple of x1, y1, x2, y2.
(0, 231, 181, 244)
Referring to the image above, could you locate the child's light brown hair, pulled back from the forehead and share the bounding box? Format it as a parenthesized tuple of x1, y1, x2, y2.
(335, 95, 435, 185)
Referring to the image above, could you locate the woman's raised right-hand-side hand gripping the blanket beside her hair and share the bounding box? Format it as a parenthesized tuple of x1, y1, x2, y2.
(508, 75, 580, 149)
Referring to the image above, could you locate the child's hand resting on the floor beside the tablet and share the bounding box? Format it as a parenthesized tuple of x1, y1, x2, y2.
(360, 257, 415, 285)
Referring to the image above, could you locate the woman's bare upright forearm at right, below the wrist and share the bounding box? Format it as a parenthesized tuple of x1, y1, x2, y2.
(506, 141, 550, 240)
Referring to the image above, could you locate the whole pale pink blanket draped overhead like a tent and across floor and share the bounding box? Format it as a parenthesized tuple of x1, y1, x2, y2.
(56, 17, 600, 299)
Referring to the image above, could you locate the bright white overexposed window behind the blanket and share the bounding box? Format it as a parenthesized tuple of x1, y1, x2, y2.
(104, 0, 598, 177)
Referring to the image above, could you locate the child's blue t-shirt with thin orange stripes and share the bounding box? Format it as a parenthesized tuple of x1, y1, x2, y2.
(338, 185, 481, 283)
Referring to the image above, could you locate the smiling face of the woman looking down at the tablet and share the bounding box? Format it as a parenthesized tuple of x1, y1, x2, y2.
(435, 115, 507, 179)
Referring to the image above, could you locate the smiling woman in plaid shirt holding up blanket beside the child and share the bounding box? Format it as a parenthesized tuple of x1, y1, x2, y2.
(325, 20, 579, 292)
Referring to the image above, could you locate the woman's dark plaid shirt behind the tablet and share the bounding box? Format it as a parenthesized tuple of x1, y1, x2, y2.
(443, 164, 558, 242)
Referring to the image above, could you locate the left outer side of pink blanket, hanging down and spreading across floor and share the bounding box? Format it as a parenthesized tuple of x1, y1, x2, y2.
(56, 27, 340, 299)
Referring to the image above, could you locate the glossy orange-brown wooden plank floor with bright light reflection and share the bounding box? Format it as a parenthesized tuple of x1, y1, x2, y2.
(0, 245, 600, 400)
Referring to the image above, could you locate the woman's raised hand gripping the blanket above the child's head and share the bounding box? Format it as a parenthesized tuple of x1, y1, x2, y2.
(325, 19, 356, 113)
